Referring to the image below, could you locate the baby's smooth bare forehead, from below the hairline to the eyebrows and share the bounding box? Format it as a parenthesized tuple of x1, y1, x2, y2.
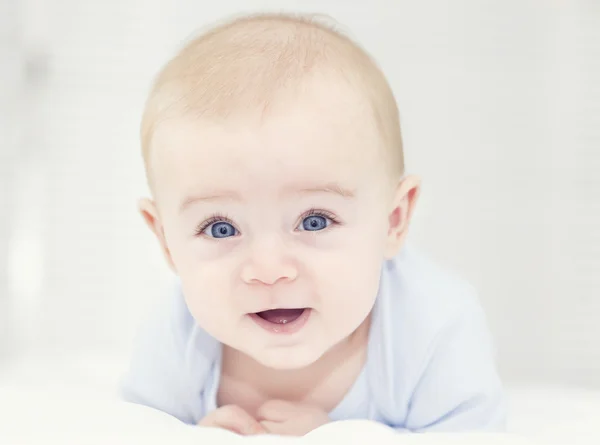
(152, 109, 386, 208)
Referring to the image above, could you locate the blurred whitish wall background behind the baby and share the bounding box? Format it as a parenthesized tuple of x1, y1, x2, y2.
(0, 0, 600, 386)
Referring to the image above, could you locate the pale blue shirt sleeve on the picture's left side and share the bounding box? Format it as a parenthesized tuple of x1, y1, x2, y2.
(120, 288, 195, 424)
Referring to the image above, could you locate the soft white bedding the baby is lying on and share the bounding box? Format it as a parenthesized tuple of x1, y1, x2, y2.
(0, 357, 600, 445)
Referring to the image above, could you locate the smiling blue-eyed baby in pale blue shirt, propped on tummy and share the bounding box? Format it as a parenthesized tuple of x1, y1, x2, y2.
(123, 15, 505, 435)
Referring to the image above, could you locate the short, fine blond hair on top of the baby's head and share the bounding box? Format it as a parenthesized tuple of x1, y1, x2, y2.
(141, 14, 404, 180)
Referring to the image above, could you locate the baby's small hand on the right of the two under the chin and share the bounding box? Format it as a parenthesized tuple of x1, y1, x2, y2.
(257, 400, 330, 436)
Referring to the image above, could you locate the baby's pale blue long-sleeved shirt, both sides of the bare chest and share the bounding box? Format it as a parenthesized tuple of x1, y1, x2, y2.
(122, 248, 506, 432)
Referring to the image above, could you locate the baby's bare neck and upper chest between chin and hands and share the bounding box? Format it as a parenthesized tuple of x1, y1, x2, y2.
(217, 319, 370, 412)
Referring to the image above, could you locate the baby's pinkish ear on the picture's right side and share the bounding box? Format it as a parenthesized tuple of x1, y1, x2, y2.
(385, 176, 421, 259)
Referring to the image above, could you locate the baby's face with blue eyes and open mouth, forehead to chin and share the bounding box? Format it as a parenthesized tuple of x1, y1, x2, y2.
(147, 79, 394, 369)
